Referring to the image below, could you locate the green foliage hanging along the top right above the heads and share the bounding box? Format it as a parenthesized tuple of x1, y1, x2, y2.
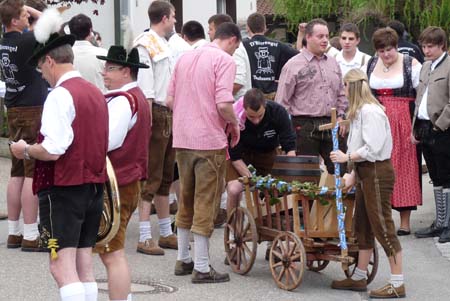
(273, 0, 450, 38)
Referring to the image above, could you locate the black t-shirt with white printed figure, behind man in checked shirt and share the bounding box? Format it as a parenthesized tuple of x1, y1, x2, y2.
(243, 35, 298, 93)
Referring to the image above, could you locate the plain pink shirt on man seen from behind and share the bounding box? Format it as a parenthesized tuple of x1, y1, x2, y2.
(168, 43, 236, 150)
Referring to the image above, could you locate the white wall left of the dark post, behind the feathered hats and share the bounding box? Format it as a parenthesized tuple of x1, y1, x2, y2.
(51, 0, 114, 49)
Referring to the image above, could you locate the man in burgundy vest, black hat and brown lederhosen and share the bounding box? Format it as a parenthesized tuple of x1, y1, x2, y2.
(96, 46, 151, 300)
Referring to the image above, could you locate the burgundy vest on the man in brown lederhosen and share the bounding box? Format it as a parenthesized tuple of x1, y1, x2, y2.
(108, 87, 152, 186)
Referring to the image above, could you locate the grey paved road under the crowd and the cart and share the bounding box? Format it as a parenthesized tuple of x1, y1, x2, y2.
(0, 158, 450, 301)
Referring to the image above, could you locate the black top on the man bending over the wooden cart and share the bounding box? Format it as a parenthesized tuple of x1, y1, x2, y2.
(229, 101, 296, 161)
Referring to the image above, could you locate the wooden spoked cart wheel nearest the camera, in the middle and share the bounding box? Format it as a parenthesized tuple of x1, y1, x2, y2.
(269, 232, 306, 291)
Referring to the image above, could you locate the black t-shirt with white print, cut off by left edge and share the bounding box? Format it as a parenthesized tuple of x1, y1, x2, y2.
(0, 31, 48, 108)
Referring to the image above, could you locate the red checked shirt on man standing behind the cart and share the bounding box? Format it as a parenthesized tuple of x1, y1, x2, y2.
(275, 49, 348, 117)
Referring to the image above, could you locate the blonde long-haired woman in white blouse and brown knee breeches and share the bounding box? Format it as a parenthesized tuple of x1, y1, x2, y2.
(330, 69, 406, 298)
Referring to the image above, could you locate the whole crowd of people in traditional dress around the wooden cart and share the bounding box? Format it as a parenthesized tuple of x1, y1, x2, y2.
(0, 0, 450, 300)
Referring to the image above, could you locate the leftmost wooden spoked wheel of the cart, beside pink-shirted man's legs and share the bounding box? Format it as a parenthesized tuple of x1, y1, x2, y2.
(224, 207, 258, 275)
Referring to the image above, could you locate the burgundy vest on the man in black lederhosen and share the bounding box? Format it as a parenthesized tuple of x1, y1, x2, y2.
(33, 77, 108, 193)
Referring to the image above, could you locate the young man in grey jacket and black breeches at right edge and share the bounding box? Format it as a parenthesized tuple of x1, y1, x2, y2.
(412, 26, 450, 243)
